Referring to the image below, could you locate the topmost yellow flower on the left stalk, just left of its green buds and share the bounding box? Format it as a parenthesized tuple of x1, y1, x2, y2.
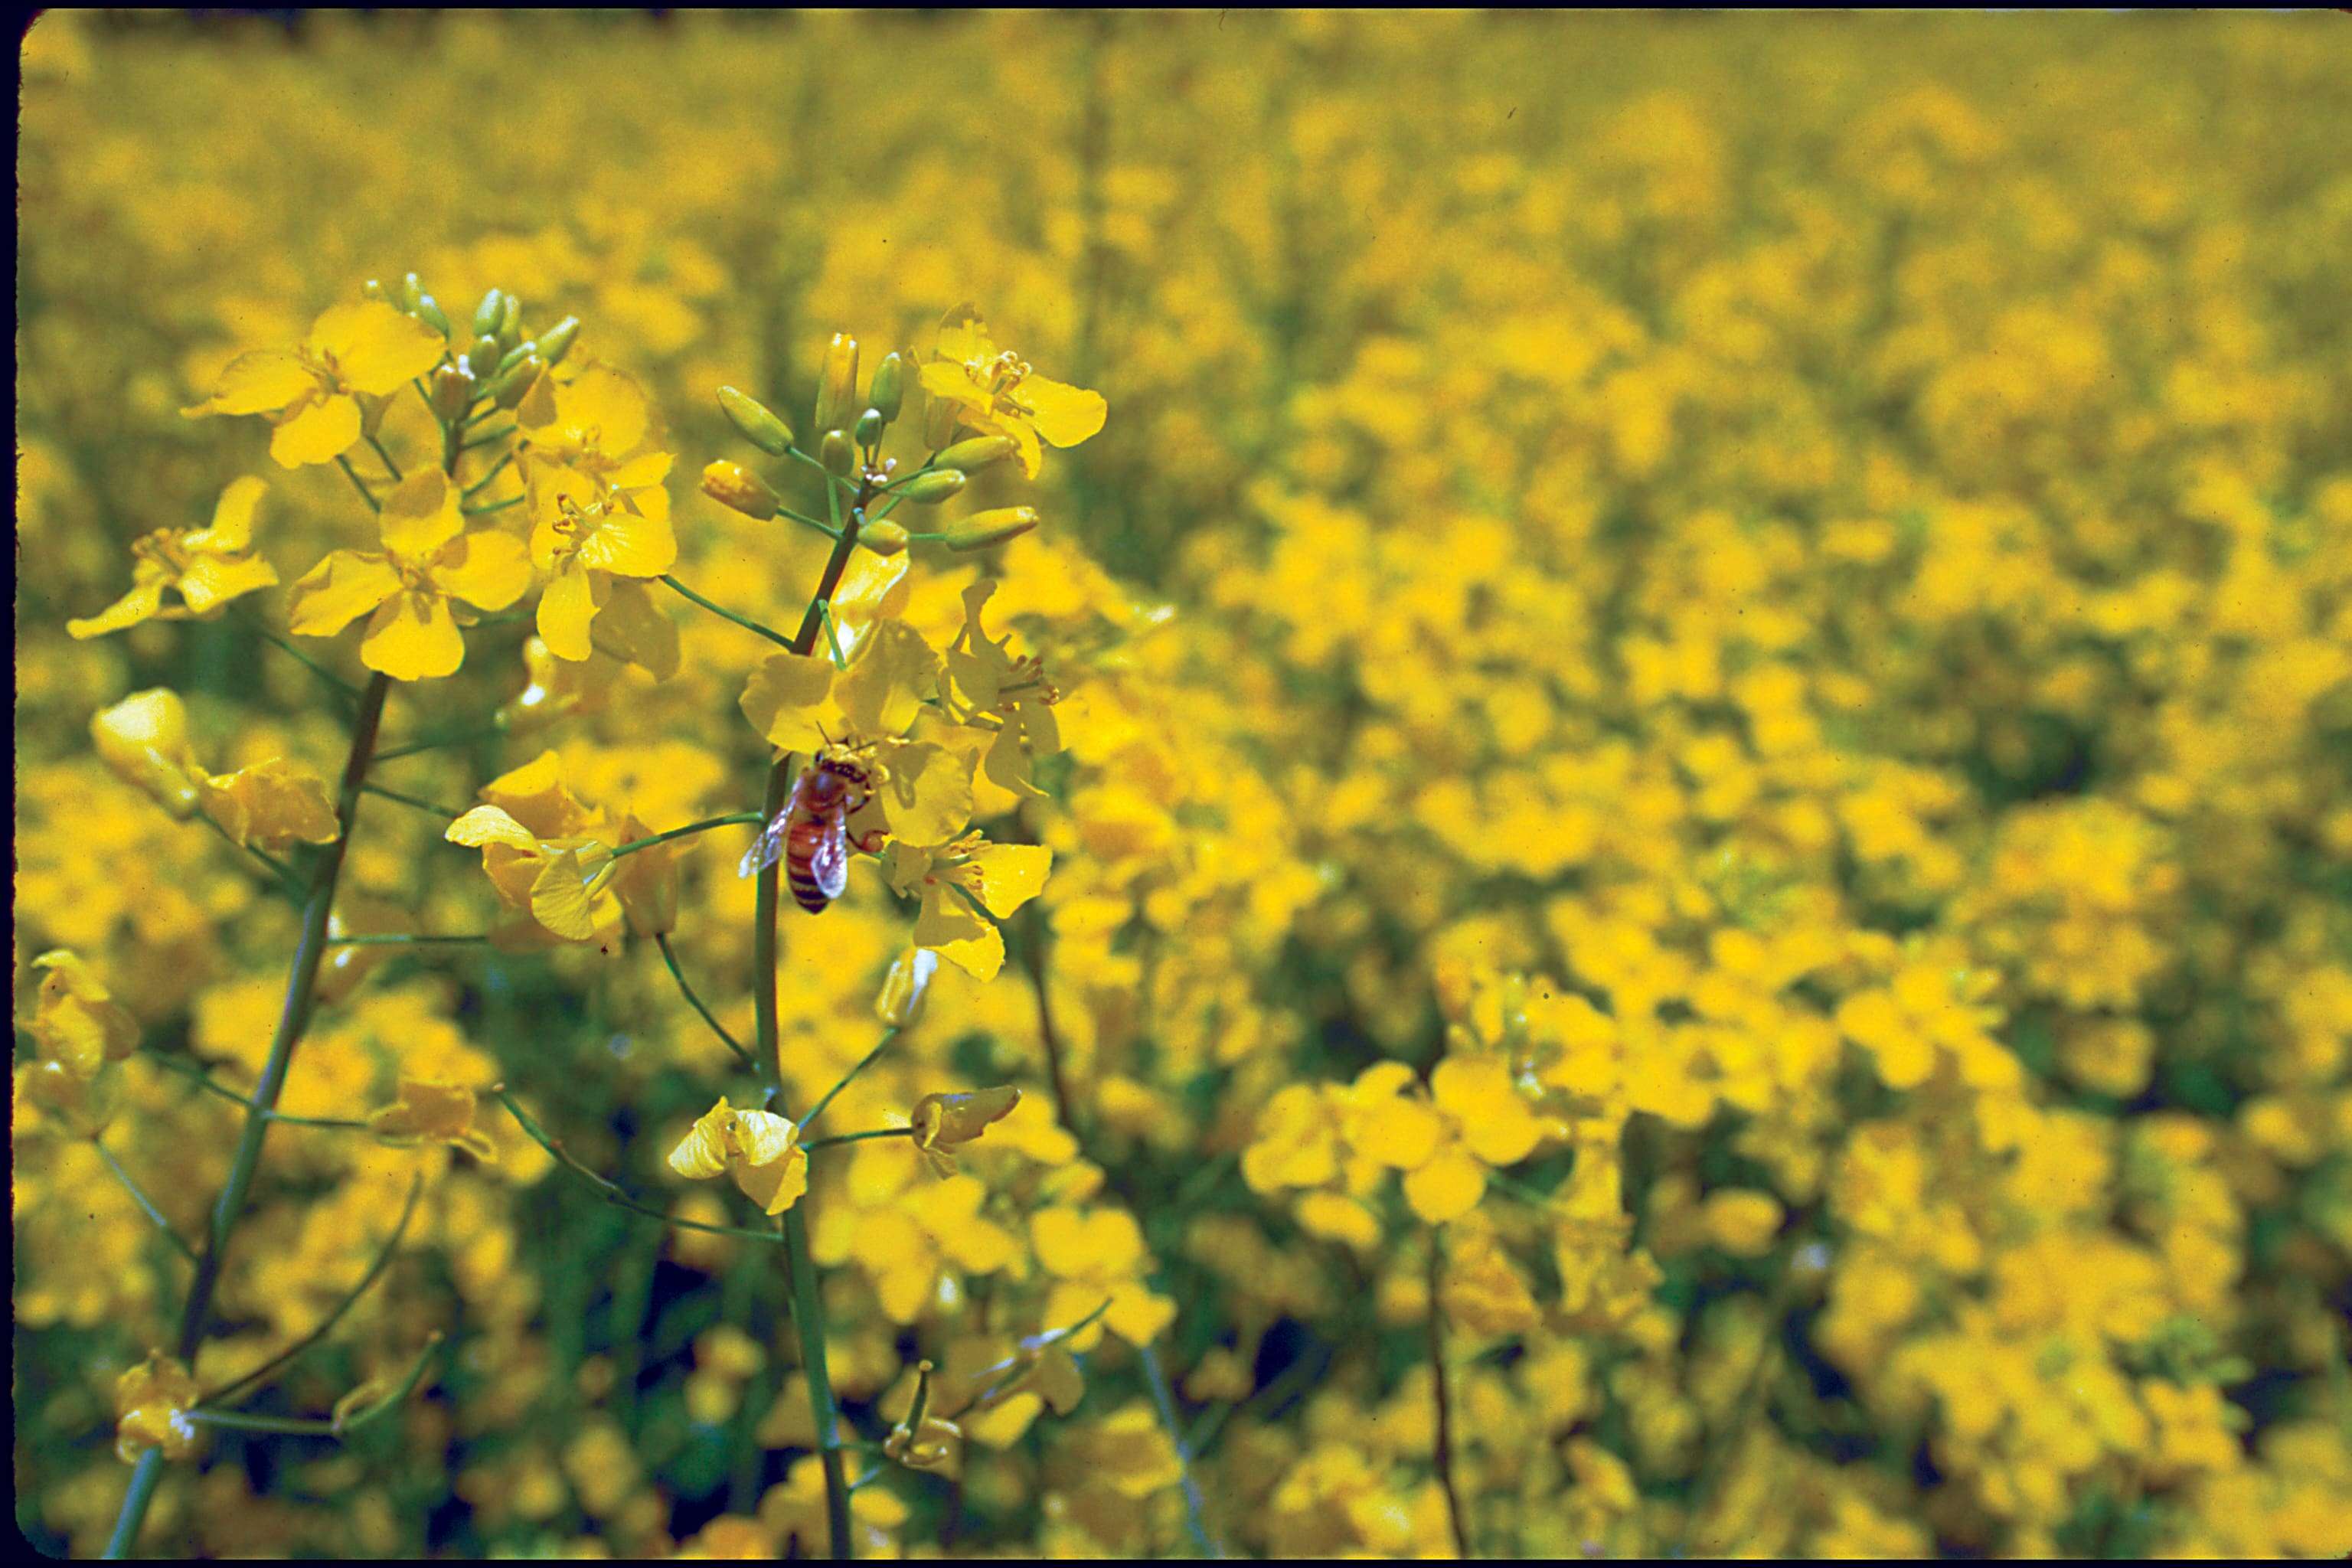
(181, 299, 447, 468)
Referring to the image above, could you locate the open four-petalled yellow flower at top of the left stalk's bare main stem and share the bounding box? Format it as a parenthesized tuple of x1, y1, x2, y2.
(287, 468, 531, 679)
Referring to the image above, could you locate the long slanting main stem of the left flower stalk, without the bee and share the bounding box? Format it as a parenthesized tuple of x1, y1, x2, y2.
(108, 672, 393, 1552)
